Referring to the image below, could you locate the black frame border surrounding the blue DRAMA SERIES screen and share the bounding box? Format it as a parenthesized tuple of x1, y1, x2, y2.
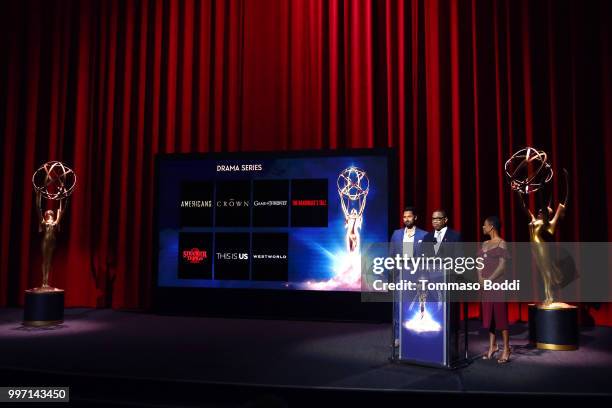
(150, 148, 399, 322)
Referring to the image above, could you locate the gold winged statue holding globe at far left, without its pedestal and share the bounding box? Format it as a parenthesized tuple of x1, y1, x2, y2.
(32, 161, 76, 292)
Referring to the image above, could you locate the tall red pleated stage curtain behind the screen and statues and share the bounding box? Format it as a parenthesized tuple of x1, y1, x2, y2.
(0, 0, 612, 324)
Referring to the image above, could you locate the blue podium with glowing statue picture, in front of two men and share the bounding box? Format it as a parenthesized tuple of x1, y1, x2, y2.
(392, 271, 467, 368)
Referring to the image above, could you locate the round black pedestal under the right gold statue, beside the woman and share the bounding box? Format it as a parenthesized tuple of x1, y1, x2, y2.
(535, 306, 579, 350)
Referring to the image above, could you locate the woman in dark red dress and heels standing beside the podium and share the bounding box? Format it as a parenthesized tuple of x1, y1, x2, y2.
(478, 216, 510, 363)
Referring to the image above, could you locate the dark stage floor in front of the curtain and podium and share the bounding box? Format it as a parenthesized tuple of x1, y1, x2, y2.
(0, 309, 612, 405)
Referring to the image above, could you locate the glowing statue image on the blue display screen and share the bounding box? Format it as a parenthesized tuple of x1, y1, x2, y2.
(308, 167, 370, 290)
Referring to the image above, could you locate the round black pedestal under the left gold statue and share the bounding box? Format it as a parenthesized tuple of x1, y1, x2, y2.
(23, 289, 64, 327)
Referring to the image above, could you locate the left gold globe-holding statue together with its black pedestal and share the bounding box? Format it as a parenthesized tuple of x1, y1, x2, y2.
(24, 161, 76, 326)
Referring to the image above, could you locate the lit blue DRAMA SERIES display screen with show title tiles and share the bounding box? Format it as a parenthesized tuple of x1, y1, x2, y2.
(157, 151, 390, 291)
